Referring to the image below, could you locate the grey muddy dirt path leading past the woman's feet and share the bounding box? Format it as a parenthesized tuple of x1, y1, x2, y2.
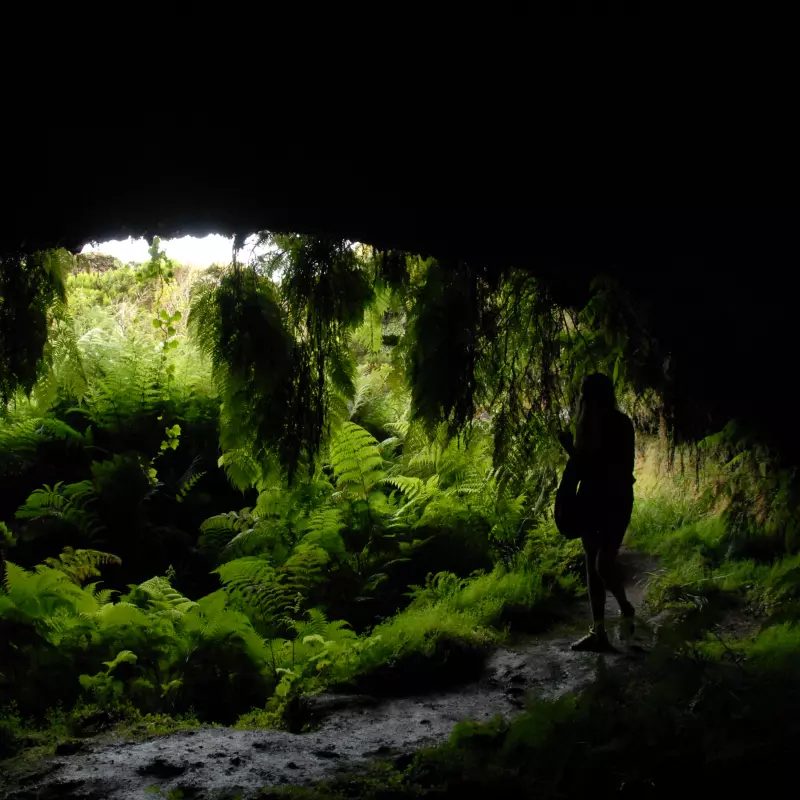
(5, 550, 655, 800)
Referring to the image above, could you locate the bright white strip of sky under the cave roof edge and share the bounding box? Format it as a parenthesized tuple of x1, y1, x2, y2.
(81, 233, 267, 267)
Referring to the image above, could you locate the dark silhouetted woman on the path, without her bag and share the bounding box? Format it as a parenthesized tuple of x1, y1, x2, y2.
(560, 373, 634, 652)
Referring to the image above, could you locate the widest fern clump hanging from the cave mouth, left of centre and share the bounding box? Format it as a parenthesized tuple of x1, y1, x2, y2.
(189, 235, 372, 482)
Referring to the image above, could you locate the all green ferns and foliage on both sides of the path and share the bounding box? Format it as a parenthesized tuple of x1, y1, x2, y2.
(0, 234, 800, 791)
